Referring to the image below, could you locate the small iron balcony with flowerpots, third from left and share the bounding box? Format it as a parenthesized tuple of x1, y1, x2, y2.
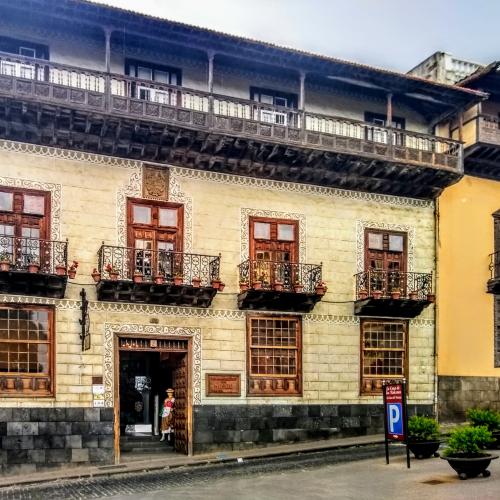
(238, 260, 326, 312)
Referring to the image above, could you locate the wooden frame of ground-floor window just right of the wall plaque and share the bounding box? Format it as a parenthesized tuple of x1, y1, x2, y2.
(246, 314, 303, 397)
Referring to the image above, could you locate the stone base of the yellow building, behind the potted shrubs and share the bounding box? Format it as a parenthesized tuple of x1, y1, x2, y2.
(438, 375, 500, 422)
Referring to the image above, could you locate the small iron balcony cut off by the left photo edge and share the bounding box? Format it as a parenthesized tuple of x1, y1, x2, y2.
(0, 236, 68, 299)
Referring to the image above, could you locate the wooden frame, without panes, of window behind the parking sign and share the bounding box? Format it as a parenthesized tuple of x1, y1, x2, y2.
(359, 318, 409, 396)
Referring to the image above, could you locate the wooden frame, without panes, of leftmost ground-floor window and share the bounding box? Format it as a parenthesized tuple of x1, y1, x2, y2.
(0, 303, 56, 398)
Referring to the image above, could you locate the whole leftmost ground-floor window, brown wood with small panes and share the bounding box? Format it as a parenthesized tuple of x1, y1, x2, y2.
(0, 305, 54, 397)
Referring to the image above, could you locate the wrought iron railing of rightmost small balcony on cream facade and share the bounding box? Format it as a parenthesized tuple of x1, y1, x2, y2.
(355, 270, 432, 300)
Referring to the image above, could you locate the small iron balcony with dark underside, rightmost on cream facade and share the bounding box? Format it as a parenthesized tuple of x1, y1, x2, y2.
(354, 271, 435, 318)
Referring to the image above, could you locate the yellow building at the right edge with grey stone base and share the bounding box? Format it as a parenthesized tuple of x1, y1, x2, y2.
(438, 63, 500, 419)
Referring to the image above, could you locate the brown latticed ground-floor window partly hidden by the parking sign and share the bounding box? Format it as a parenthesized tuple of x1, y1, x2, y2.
(361, 320, 407, 393)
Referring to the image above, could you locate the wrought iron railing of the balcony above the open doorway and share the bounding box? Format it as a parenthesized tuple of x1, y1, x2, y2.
(98, 245, 220, 287)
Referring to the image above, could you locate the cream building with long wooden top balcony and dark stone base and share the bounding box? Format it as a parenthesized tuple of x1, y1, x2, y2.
(0, 0, 483, 472)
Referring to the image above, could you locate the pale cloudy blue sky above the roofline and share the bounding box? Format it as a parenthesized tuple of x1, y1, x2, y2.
(96, 0, 500, 72)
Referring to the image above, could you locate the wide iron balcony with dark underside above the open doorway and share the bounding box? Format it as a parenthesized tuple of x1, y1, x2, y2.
(96, 245, 224, 307)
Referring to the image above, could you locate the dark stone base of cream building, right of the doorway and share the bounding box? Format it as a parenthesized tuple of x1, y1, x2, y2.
(193, 404, 433, 453)
